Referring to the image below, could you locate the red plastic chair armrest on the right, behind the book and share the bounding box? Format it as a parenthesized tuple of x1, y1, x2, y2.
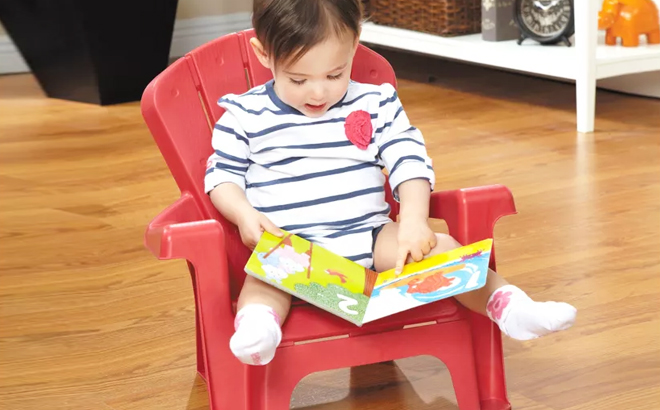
(429, 185, 517, 250)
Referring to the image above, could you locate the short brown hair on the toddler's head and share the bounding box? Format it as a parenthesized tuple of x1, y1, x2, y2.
(252, 0, 363, 64)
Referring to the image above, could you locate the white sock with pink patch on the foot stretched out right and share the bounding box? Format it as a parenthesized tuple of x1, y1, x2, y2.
(486, 285, 577, 340)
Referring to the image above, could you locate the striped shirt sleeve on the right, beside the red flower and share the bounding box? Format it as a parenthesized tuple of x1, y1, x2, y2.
(375, 84, 435, 201)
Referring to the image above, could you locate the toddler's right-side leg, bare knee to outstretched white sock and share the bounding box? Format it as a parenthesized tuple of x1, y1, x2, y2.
(374, 222, 576, 340)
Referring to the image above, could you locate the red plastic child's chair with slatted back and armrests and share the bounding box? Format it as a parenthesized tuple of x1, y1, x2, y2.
(141, 30, 516, 410)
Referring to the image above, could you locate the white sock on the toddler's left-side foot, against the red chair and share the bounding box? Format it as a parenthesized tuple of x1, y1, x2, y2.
(229, 304, 282, 365)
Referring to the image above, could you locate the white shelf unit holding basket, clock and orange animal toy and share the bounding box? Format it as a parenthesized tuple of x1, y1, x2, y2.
(361, 0, 660, 132)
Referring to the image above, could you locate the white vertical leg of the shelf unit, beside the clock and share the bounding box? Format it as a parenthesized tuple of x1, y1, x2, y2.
(575, 0, 598, 132)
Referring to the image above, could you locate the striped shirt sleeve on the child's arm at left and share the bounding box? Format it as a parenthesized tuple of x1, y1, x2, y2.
(204, 107, 250, 194)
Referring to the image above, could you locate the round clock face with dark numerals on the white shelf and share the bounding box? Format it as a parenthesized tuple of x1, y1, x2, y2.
(518, 0, 572, 37)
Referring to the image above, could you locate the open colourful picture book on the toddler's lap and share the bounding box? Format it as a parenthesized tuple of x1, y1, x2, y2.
(245, 232, 493, 326)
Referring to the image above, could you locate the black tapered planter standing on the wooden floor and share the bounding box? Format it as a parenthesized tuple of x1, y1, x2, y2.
(0, 0, 177, 105)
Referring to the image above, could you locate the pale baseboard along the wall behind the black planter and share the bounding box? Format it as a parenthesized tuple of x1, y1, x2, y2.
(0, 13, 252, 74)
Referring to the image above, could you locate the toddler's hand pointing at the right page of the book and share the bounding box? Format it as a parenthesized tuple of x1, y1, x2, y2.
(395, 218, 437, 275)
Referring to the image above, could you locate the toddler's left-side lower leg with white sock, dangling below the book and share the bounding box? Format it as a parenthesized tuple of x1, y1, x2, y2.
(229, 275, 291, 365)
